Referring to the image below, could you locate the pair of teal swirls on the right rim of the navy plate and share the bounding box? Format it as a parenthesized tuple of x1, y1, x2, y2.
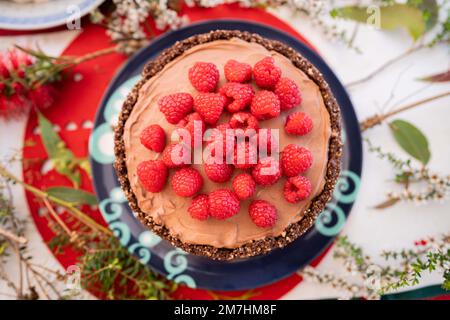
(315, 170, 361, 237)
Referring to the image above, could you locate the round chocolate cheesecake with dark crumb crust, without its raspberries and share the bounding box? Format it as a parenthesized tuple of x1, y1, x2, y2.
(115, 30, 342, 260)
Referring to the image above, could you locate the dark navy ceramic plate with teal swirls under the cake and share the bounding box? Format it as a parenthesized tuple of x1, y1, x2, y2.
(89, 20, 362, 290)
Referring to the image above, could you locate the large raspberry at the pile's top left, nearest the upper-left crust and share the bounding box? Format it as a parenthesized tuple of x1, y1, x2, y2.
(189, 62, 219, 92)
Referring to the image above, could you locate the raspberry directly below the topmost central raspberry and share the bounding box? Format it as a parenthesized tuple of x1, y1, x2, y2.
(219, 82, 255, 112)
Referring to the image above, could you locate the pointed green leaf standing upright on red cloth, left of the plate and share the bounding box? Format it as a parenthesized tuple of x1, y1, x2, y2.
(38, 113, 81, 187)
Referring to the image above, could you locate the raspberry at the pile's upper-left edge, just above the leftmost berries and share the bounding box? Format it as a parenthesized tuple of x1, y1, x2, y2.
(158, 92, 194, 124)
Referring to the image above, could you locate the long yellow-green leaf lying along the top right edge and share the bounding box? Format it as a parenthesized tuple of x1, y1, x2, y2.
(330, 3, 426, 40)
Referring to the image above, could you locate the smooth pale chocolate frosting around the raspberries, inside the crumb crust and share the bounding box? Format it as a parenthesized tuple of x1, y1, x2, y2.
(123, 38, 331, 248)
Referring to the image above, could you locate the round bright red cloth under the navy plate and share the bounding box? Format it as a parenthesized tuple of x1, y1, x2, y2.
(23, 5, 323, 299)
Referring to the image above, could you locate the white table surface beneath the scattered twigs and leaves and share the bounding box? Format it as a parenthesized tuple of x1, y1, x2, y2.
(0, 9, 450, 299)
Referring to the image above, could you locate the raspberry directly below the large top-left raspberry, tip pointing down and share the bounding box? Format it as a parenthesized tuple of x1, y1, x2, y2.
(194, 93, 227, 125)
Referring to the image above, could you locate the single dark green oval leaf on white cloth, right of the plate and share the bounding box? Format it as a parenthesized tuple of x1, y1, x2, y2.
(389, 120, 431, 165)
